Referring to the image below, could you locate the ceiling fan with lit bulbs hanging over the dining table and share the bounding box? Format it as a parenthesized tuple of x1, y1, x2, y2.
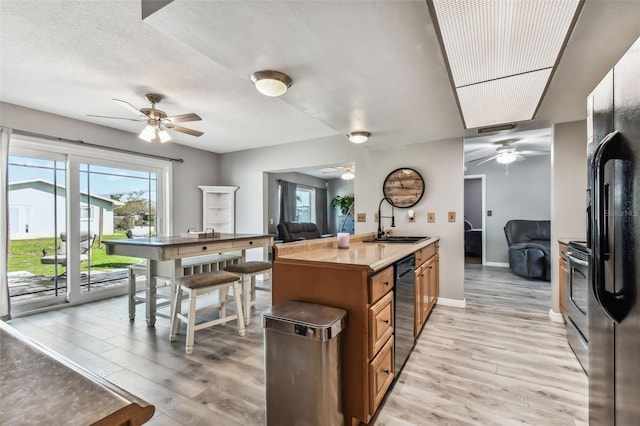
(87, 93, 204, 143)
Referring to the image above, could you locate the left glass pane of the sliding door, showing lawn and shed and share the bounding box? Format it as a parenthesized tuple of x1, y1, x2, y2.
(8, 152, 67, 307)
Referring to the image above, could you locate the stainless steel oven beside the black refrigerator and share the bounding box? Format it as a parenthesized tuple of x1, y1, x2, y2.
(566, 241, 589, 374)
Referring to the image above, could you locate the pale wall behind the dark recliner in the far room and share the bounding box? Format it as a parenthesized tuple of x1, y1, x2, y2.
(466, 155, 551, 264)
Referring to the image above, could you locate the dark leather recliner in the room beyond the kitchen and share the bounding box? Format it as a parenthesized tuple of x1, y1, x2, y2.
(504, 220, 551, 281)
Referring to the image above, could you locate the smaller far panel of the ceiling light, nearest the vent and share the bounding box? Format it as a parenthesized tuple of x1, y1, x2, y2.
(457, 69, 551, 128)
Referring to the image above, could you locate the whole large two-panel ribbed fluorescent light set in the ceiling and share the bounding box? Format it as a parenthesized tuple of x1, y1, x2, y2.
(427, 0, 584, 129)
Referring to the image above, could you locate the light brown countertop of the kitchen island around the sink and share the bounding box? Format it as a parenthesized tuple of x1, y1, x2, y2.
(274, 233, 440, 272)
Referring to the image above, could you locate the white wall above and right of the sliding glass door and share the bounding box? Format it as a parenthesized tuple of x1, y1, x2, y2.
(0, 102, 220, 233)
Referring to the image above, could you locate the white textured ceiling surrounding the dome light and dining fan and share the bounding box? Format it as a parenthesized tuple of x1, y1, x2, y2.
(0, 0, 640, 153)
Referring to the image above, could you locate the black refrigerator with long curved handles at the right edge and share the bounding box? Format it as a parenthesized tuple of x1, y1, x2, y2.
(587, 38, 640, 426)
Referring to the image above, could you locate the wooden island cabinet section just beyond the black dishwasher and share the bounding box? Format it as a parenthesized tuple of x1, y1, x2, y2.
(414, 244, 440, 338)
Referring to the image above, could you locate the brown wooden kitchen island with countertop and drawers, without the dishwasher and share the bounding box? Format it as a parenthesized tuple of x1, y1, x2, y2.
(272, 233, 439, 425)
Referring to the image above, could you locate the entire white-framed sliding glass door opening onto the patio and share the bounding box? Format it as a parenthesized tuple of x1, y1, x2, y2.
(8, 139, 170, 313)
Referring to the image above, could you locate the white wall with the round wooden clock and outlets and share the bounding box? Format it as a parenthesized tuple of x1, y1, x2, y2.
(220, 136, 464, 300)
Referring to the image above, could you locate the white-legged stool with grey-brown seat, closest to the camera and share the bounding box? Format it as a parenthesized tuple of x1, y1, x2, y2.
(169, 271, 245, 355)
